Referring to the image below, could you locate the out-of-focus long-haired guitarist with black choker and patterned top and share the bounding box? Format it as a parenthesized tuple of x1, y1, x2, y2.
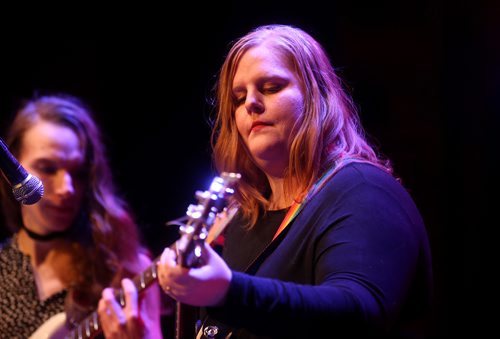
(0, 95, 162, 338)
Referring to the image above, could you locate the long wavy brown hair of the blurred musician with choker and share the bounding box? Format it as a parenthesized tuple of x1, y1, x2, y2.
(0, 94, 147, 318)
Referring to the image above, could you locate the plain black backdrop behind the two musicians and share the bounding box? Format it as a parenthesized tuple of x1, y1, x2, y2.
(0, 0, 500, 338)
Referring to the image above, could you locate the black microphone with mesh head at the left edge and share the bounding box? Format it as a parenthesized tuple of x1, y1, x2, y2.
(0, 138, 43, 205)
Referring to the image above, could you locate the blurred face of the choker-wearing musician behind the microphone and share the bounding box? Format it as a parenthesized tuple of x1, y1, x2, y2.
(19, 121, 86, 234)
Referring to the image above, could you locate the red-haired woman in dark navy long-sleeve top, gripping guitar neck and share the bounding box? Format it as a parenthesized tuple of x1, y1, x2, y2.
(158, 25, 432, 338)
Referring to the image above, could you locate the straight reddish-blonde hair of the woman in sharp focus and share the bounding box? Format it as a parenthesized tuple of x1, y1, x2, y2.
(211, 25, 392, 224)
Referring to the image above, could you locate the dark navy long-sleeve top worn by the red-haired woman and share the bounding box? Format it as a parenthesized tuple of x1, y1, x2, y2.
(206, 163, 432, 338)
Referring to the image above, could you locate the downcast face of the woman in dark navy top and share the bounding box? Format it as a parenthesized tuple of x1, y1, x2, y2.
(232, 45, 304, 177)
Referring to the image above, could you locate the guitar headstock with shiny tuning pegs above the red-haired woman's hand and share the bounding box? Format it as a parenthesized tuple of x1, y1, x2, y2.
(177, 172, 241, 267)
